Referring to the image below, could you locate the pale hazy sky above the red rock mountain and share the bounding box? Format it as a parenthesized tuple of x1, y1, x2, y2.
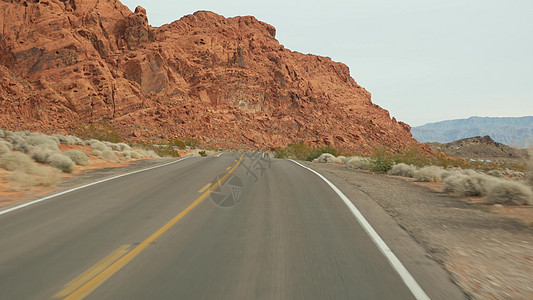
(122, 0, 533, 126)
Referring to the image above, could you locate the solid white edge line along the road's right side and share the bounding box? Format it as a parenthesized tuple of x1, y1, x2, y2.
(289, 159, 430, 300)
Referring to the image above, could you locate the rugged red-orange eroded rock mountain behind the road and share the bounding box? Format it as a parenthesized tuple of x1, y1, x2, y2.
(0, 0, 424, 152)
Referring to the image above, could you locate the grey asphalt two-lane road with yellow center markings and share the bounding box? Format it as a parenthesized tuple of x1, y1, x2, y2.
(0, 153, 458, 299)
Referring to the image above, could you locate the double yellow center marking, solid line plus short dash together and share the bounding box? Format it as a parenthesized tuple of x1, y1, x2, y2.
(54, 154, 244, 300)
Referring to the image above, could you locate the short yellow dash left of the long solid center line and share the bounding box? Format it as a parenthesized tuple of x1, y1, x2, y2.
(54, 245, 132, 298)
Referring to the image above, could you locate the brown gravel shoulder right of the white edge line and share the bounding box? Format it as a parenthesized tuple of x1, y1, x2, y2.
(302, 162, 533, 299)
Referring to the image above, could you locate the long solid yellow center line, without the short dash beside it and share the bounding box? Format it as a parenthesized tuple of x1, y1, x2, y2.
(57, 154, 244, 300)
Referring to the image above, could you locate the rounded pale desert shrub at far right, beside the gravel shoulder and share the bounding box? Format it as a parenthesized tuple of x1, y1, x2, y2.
(485, 180, 533, 205)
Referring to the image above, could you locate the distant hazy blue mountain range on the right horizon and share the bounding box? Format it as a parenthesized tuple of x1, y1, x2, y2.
(411, 116, 533, 148)
